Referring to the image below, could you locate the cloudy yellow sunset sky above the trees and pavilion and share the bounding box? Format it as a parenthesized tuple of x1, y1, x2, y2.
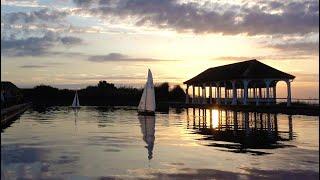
(1, 0, 319, 98)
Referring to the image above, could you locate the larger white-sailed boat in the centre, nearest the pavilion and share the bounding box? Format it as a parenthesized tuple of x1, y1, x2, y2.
(138, 69, 156, 115)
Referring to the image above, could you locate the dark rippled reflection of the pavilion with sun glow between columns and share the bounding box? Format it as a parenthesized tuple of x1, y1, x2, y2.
(187, 108, 293, 154)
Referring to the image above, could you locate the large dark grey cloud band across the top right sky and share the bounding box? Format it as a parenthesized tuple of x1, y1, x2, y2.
(74, 0, 319, 35)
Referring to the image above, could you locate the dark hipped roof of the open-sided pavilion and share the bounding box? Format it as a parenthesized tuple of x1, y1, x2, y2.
(183, 59, 295, 85)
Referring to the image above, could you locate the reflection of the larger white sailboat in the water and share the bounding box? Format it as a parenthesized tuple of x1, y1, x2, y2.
(138, 116, 155, 159)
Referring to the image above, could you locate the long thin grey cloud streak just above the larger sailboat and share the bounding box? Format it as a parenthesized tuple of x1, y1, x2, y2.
(88, 53, 178, 62)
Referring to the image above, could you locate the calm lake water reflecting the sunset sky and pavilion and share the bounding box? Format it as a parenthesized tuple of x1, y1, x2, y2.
(1, 107, 319, 179)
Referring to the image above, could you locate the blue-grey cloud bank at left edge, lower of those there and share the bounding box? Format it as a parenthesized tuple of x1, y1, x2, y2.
(1, 32, 82, 56)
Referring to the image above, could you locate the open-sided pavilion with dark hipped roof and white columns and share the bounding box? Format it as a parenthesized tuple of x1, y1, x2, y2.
(184, 59, 295, 106)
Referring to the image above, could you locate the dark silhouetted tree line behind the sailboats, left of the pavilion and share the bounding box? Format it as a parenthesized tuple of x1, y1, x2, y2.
(21, 81, 185, 107)
